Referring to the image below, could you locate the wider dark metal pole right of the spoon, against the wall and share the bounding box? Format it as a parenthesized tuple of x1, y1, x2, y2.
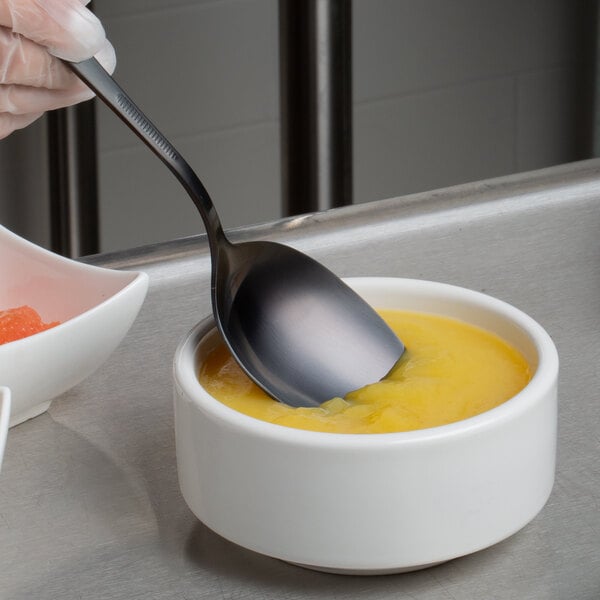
(279, 0, 352, 215)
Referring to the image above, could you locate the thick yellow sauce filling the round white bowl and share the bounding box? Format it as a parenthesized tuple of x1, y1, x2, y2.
(199, 310, 531, 433)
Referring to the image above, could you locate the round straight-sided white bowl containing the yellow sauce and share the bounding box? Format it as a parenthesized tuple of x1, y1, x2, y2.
(174, 278, 558, 574)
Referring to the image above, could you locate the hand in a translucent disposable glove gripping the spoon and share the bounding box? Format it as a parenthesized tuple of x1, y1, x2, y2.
(0, 0, 116, 139)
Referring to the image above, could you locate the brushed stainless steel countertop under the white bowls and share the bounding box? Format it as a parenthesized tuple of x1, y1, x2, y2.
(0, 160, 600, 600)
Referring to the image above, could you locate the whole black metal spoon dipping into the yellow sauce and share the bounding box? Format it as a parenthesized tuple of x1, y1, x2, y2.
(69, 58, 404, 406)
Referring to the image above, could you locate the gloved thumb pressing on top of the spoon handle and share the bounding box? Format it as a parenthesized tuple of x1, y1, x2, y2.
(0, 0, 106, 62)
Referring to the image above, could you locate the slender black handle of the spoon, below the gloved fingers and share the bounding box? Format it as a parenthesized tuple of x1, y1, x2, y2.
(65, 58, 227, 250)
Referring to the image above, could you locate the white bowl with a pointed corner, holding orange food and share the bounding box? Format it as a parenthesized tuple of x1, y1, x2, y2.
(0, 226, 148, 426)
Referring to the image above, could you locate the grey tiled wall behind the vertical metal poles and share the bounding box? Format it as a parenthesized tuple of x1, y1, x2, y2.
(0, 0, 593, 251)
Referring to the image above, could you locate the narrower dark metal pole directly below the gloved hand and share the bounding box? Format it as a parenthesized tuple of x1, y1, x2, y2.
(48, 100, 99, 257)
